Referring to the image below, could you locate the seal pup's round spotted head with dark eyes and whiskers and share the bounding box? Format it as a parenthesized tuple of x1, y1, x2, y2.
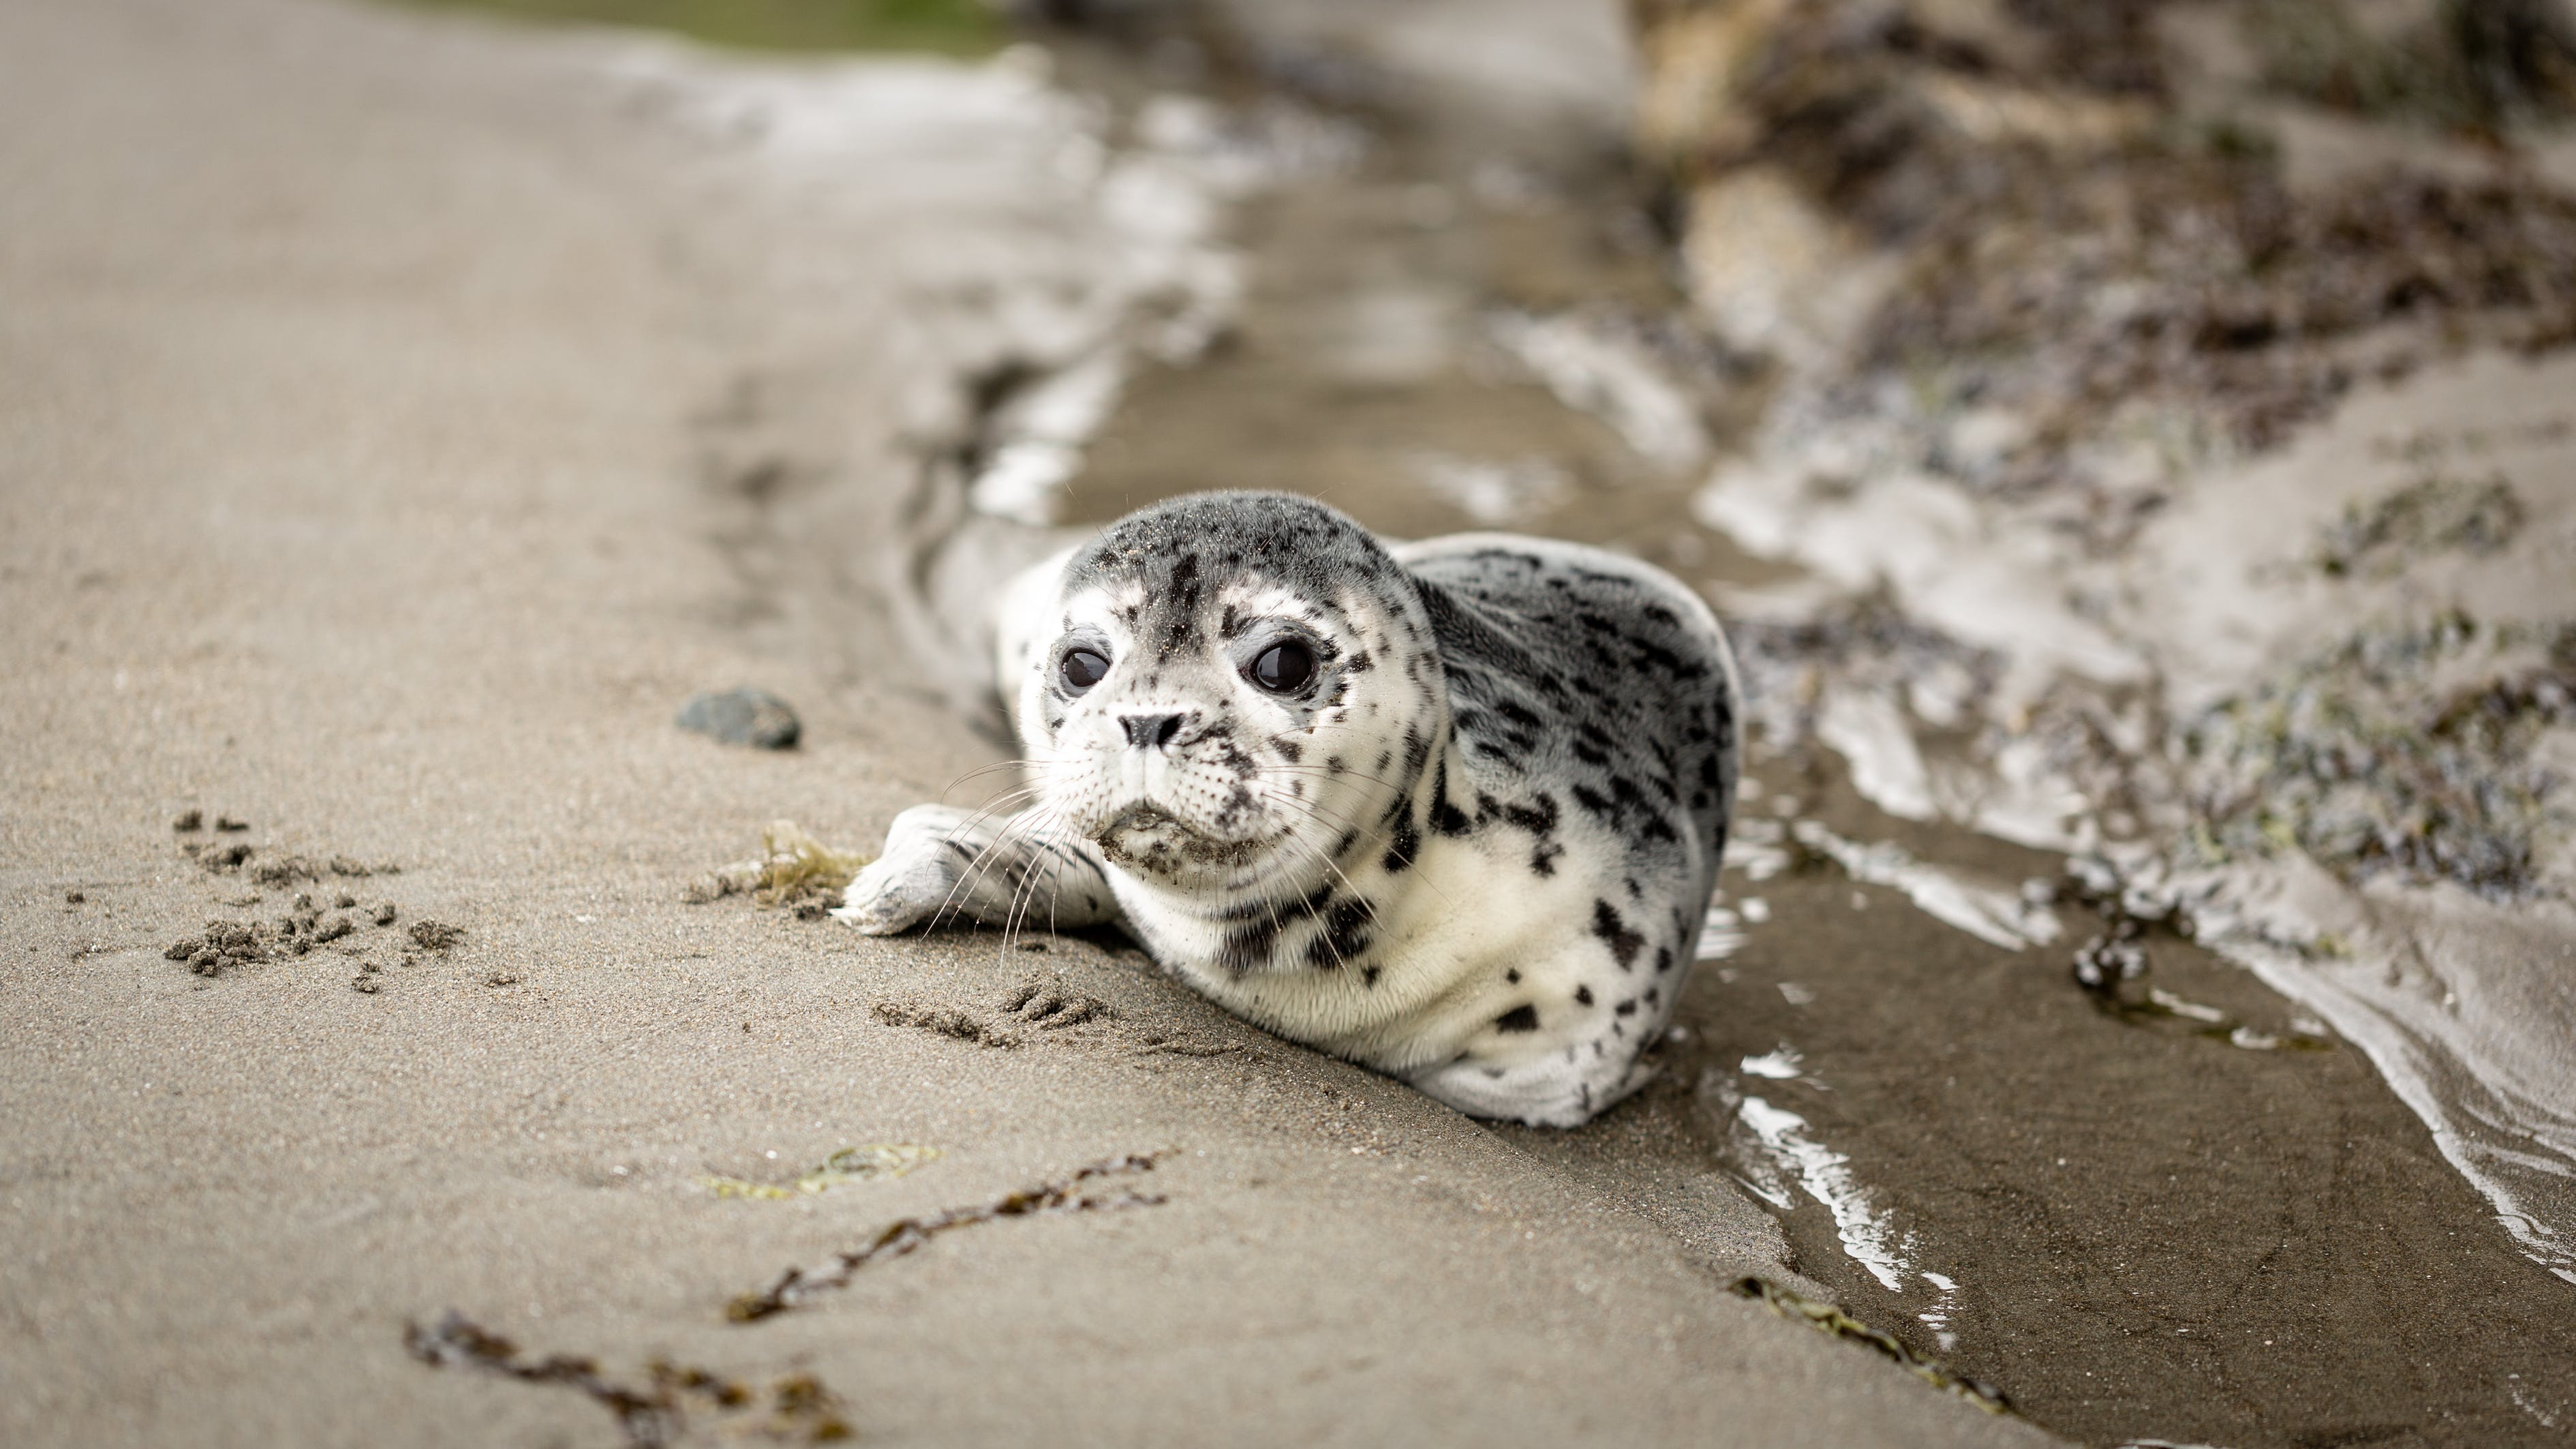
(1017, 493, 1447, 913)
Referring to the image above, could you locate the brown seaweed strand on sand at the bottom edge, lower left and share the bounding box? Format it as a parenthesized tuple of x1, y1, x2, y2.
(402, 1310, 853, 1449)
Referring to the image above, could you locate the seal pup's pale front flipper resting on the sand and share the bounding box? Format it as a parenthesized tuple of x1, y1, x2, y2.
(832, 804, 1118, 936)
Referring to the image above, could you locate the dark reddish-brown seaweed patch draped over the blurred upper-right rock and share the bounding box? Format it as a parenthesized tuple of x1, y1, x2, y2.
(1862, 160, 2576, 490)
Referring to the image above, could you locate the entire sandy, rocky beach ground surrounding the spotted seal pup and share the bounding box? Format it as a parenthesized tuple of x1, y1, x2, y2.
(20, 0, 2576, 1449)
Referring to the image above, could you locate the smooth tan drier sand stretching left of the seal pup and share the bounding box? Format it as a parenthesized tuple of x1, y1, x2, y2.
(0, 0, 2040, 1444)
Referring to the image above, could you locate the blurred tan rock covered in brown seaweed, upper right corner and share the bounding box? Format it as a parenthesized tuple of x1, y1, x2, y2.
(1638, 0, 2576, 547)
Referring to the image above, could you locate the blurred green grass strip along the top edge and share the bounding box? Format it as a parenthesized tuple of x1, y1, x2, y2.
(399, 0, 1007, 57)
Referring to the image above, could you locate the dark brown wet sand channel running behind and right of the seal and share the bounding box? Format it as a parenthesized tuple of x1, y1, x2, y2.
(1045, 14, 2576, 1444)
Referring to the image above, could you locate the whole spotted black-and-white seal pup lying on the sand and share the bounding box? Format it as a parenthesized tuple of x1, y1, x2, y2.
(835, 493, 1736, 1127)
